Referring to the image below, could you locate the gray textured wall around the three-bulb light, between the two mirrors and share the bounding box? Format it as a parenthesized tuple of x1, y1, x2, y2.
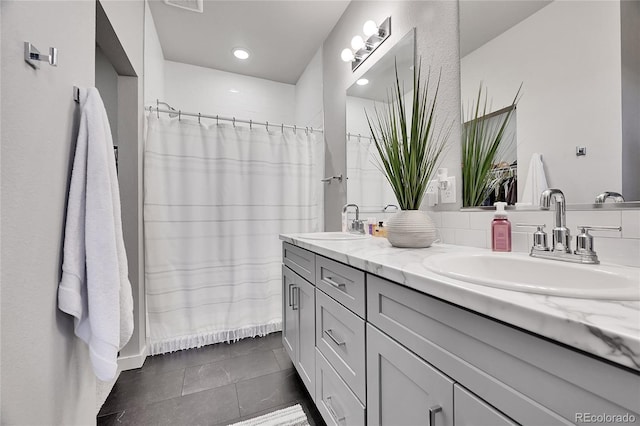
(322, 1, 462, 231)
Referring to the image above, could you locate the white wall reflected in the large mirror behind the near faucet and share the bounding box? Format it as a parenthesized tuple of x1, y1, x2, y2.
(461, 1, 624, 203)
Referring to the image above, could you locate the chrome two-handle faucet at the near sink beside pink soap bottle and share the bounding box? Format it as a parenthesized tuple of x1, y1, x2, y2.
(517, 189, 622, 264)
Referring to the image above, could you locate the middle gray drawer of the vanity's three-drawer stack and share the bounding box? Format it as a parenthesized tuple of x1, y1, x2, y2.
(316, 288, 365, 401)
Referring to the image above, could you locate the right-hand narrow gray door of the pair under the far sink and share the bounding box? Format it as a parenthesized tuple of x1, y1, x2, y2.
(293, 276, 316, 399)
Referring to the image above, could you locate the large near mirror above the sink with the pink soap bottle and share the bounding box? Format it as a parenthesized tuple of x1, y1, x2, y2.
(460, 0, 640, 204)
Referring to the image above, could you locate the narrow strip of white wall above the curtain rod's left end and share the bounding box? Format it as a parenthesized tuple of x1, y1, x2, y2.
(144, 0, 165, 106)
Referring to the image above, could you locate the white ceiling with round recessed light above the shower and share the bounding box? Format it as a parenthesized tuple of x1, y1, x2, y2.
(149, 0, 349, 84)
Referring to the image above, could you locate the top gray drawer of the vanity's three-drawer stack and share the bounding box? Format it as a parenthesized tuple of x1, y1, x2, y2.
(316, 256, 365, 318)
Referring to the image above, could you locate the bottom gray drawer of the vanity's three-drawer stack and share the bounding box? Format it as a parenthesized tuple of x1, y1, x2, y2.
(316, 348, 365, 426)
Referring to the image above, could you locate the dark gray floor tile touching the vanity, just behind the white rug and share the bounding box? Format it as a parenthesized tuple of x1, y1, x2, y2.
(236, 370, 306, 417)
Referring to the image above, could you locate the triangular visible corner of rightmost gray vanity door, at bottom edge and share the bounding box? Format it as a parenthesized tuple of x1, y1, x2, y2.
(453, 384, 518, 426)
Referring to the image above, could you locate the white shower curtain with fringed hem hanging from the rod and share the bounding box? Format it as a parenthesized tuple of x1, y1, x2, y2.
(144, 114, 324, 354)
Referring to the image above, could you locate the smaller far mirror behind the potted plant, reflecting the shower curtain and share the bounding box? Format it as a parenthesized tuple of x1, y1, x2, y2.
(346, 29, 415, 212)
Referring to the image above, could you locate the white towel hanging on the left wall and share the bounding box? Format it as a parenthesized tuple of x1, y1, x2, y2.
(58, 88, 133, 381)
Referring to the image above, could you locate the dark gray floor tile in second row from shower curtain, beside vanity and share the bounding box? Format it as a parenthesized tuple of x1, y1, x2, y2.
(182, 350, 280, 395)
